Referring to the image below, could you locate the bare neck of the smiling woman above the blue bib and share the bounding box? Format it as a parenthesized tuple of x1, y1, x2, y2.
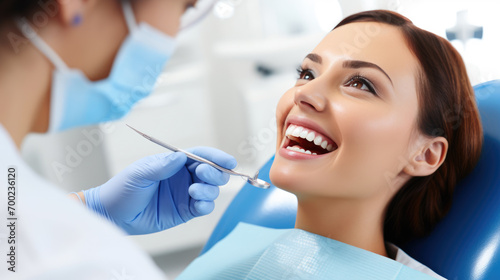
(295, 197, 387, 256)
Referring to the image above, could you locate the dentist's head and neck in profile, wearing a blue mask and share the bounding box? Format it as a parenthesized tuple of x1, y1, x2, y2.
(0, 0, 197, 142)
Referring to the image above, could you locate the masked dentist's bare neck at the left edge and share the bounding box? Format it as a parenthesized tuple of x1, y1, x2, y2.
(0, 22, 53, 148)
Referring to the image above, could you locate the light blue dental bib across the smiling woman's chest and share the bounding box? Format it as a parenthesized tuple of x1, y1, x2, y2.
(177, 223, 435, 280)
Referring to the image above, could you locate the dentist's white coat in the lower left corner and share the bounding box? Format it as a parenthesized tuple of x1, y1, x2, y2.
(0, 126, 165, 280)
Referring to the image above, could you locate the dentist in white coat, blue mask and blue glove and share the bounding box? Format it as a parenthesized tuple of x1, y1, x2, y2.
(0, 0, 236, 280)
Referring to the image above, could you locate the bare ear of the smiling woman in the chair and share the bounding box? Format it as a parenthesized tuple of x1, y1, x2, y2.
(403, 137, 448, 176)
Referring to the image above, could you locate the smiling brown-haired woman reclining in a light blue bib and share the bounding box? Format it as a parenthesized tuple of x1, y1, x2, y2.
(181, 11, 482, 279)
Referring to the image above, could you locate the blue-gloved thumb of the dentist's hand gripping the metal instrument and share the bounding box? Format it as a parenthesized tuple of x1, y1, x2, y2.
(129, 152, 187, 185)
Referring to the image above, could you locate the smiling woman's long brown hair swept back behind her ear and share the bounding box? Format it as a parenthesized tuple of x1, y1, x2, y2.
(334, 10, 483, 244)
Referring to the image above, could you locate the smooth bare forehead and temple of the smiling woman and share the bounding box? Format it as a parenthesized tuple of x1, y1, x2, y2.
(305, 22, 420, 106)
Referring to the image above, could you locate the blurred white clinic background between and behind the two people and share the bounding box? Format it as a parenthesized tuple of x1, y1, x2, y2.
(23, 0, 500, 277)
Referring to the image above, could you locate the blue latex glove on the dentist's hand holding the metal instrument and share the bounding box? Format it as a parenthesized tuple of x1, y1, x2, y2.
(84, 147, 236, 234)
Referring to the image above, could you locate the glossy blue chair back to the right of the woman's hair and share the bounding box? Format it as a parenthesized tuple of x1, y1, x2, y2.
(404, 80, 500, 279)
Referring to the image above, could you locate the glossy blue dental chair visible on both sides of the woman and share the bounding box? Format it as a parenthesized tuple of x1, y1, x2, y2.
(202, 80, 500, 280)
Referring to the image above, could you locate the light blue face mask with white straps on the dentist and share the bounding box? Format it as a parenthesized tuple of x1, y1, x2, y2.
(18, 1, 175, 132)
